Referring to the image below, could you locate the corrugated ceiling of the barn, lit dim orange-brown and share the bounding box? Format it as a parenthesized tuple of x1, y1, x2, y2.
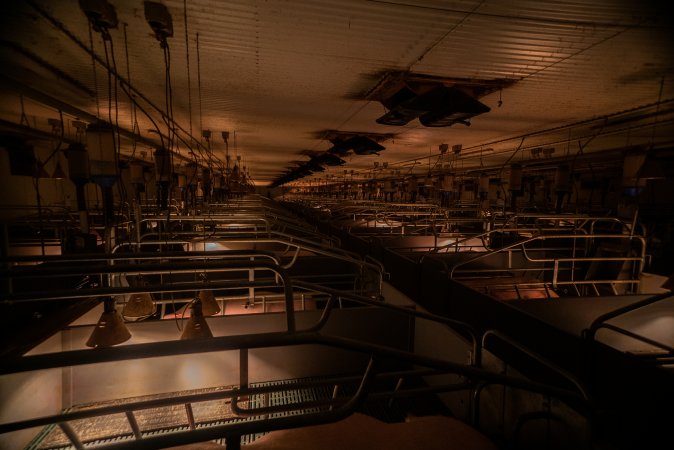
(0, 0, 674, 185)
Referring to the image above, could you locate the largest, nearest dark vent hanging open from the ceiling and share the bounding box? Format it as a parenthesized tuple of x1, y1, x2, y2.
(377, 85, 491, 127)
